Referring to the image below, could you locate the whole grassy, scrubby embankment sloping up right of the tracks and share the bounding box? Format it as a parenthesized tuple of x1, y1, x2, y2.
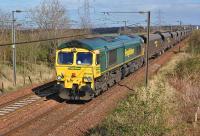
(86, 31, 200, 136)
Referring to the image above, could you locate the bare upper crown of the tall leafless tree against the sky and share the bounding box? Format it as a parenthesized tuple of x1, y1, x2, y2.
(32, 0, 68, 30)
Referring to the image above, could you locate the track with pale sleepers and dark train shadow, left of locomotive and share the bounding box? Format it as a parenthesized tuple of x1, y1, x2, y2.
(0, 81, 56, 117)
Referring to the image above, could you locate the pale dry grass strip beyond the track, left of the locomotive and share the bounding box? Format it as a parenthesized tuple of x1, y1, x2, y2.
(0, 63, 55, 93)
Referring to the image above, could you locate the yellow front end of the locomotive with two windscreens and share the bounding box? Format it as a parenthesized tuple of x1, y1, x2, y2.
(56, 48, 101, 100)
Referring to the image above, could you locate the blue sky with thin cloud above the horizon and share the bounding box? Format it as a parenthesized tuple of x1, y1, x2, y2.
(0, 0, 200, 26)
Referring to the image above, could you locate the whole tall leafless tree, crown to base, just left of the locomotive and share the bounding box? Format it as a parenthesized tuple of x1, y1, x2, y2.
(31, 0, 69, 62)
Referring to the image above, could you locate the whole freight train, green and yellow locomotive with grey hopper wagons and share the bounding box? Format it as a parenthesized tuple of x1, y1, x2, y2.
(55, 30, 191, 100)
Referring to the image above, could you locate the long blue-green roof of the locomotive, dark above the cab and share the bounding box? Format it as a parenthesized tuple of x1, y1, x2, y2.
(58, 35, 142, 50)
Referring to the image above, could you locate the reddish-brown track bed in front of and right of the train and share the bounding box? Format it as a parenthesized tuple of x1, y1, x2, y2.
(0, 39, 187, 136)
